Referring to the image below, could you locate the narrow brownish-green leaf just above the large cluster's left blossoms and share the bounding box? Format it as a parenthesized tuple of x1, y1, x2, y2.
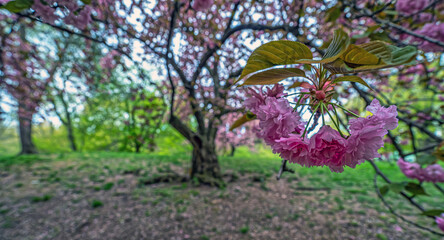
(241, 68, 306, 86)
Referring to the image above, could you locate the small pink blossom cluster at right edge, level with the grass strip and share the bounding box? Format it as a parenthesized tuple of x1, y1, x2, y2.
(398, 159, 444, 183)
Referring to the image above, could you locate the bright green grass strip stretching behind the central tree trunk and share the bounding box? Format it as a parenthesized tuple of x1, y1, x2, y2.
(0, 148, 442, 218)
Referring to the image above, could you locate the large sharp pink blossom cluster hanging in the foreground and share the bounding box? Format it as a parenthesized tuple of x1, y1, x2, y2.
(245, 84, 398, 172)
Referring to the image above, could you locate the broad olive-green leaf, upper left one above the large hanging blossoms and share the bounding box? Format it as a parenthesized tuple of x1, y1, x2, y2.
(235, 40, 313, 83)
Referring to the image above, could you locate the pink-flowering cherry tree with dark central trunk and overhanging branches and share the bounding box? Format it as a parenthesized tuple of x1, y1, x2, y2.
(0, 0, 444, 234)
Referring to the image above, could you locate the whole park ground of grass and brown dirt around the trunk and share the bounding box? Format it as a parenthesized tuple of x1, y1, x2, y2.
(0, 149, 442, 240)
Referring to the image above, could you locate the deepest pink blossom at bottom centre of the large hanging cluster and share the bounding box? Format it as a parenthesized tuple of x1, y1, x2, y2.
(310, 125, 346, 172)
